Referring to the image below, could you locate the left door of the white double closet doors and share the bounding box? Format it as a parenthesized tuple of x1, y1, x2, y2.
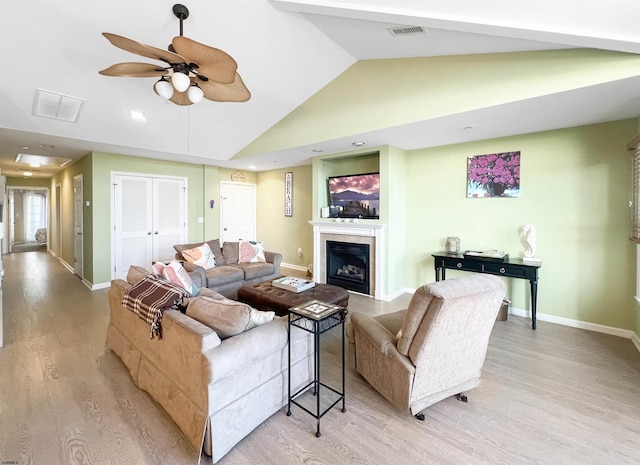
(114, 176, 153, 279)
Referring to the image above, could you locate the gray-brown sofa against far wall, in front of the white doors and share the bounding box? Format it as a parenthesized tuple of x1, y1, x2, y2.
(173, 239, 282, 299)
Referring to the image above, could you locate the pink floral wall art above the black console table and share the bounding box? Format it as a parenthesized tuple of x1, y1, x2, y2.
(467, 152, 520, 198)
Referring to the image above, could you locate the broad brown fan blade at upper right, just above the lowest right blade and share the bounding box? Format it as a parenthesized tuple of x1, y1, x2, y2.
(171, 36, 238, 84)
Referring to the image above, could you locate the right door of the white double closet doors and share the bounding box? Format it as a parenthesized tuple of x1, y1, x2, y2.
(153, 178, 186, 260)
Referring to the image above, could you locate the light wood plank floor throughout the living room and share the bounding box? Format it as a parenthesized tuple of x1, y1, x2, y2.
(0, 252, 640, 465)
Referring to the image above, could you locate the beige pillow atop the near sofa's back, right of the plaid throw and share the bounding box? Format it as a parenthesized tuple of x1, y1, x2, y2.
(186, 296, 274, 339)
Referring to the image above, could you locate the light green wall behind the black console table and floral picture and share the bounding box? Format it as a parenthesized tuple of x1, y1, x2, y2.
(405, 120, 637, 331)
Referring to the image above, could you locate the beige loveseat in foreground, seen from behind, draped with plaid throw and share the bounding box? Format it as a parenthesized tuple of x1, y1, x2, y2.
(105, 280, 313, 462)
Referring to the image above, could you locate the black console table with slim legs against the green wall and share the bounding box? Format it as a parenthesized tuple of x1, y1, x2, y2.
(431, 252, 542, 329)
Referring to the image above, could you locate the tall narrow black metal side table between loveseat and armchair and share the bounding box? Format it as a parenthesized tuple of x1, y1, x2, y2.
(287, 300, 347, 437)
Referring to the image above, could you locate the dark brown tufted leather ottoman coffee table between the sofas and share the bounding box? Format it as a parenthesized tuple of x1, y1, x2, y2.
(238, 281, 349, 316)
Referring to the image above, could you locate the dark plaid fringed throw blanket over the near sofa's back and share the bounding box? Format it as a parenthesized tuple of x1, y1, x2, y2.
(122, 275, 190, 339)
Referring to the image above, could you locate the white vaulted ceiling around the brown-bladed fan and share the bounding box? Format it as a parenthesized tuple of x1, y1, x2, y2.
(0, 0, 640, 176)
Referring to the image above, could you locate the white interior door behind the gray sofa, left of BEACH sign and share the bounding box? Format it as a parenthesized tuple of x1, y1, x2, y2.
(220, 182, 256, 242)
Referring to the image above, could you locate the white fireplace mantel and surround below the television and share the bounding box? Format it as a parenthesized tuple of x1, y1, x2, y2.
(309, 219, 385, 300)
